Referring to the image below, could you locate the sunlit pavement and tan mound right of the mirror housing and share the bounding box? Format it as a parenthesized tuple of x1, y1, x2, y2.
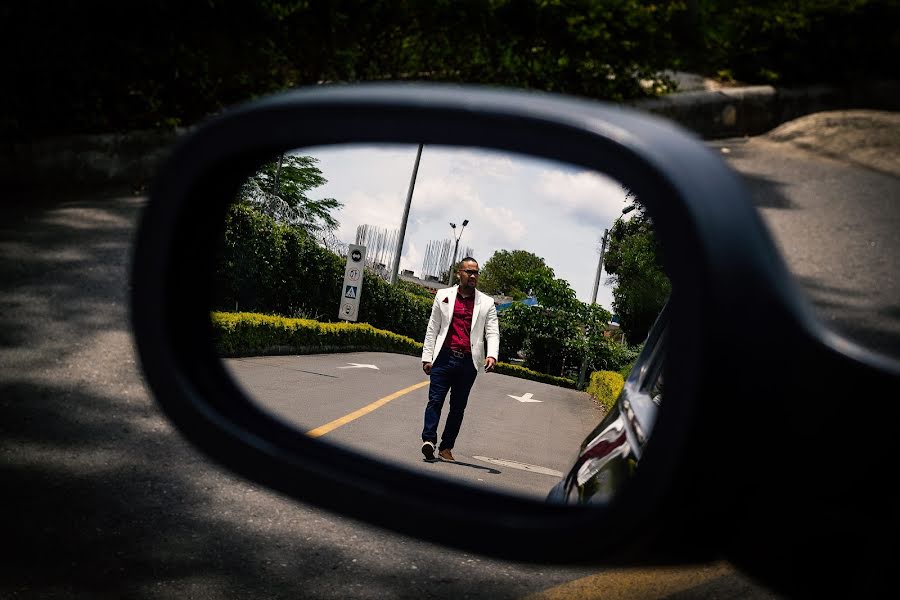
(710, 111, 900, 359)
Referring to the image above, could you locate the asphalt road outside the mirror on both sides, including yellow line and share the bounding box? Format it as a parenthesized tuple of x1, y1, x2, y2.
(0, 110, 900, 599)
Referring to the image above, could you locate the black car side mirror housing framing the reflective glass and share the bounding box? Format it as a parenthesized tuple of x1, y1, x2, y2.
(132, 84, 896, 580)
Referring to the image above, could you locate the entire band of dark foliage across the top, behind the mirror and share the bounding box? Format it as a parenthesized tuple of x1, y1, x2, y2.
(8, 0, 900, 140)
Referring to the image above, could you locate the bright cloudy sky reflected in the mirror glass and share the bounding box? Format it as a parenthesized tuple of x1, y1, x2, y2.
(296, 145, 631, 310)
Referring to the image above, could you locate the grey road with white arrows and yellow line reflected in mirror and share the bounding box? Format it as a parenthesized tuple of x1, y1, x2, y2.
(226, 352, 603, 501)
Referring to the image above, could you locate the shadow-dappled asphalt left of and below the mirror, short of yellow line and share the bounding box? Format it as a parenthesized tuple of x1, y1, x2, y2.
(0, 190, 604, 599)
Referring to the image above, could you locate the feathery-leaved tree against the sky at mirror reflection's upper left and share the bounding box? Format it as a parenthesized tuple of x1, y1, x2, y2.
(240, 154, 343, 233)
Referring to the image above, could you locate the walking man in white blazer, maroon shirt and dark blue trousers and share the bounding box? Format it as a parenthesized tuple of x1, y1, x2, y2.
(422, 256, 500, 460)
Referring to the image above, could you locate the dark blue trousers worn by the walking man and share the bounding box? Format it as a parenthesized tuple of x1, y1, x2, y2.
(422, 349, 478, 450)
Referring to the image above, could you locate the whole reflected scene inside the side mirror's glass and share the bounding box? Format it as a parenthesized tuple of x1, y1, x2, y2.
(213, 145, 669, 501)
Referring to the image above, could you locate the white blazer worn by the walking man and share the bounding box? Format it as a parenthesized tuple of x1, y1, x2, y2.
(422, 285, 500, 372)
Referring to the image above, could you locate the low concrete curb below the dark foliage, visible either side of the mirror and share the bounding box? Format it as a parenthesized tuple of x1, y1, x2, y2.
(7, 81, 900, 192)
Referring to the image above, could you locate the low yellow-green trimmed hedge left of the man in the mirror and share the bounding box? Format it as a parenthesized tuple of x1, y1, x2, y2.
(211, 312, 422, 356)
